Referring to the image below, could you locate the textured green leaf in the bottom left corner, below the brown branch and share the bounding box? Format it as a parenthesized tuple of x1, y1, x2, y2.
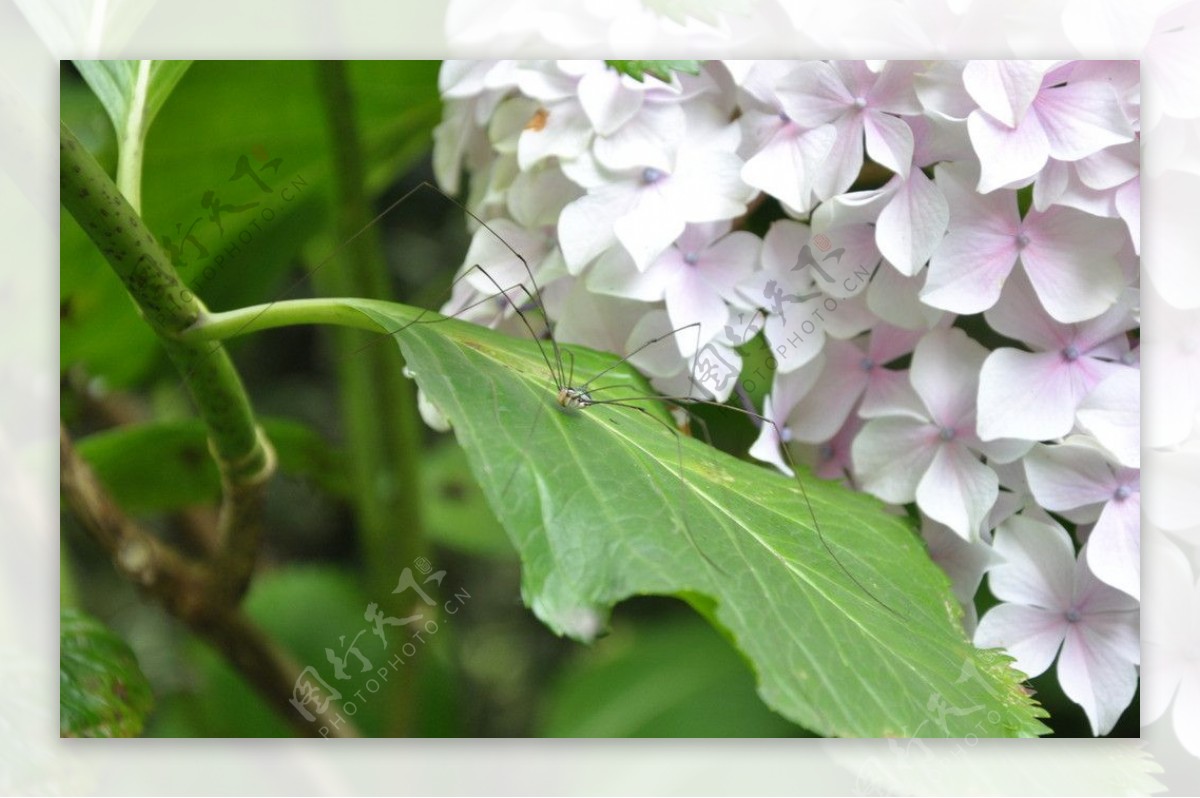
(59, 610, 154, 737)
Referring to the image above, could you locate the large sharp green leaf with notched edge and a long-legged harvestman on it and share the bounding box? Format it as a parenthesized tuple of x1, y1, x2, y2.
(302, 300, 1045, 737)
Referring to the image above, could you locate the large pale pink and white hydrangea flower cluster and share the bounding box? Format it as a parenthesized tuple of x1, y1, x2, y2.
(434, 61, 1140, 734)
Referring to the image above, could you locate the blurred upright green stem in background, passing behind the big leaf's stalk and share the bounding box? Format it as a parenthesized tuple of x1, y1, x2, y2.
(313, 61, 425, 737)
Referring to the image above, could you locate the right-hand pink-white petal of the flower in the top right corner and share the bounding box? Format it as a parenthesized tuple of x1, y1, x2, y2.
(1033, 82, 1133, 161)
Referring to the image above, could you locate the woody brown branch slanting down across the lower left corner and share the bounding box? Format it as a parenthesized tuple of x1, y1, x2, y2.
(59, 425, 359, 737)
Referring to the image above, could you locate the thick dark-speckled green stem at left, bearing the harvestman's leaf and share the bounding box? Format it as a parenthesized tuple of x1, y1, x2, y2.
(59, 125, 275, 601)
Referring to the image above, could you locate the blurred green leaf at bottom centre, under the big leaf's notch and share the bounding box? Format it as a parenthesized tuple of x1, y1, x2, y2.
(541, 609, 799, 737)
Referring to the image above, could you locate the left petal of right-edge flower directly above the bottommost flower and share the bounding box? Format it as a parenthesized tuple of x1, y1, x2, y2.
(1025, 444, 1117, 512)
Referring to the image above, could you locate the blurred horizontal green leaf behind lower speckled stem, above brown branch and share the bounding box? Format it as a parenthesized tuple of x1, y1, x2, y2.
(78, 419, 349, 512)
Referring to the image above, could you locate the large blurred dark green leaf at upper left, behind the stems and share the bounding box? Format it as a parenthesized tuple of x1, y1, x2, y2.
(60, 61, 440, 388)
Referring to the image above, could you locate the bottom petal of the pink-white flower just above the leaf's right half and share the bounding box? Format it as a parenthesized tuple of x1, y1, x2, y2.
(917, 443, 1000, 540)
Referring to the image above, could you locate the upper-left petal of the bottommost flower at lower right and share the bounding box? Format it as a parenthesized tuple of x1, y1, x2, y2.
(988, 515, 1075, 609)
